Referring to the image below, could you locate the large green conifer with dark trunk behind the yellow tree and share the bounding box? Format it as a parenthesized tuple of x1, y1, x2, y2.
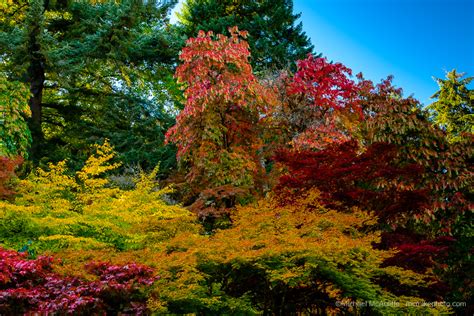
(0, 0, 180, 172)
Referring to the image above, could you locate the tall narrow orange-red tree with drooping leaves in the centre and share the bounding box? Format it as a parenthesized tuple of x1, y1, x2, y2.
(166, 27, 272, 210)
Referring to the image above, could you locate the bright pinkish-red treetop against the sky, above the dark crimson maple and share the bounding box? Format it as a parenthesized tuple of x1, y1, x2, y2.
(273, 54, 362, 149)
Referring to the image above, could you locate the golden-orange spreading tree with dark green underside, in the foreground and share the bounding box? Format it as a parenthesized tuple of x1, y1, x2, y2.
(152, 191, 448, 314)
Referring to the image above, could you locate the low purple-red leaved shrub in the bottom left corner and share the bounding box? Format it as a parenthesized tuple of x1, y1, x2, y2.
(0, 248, 157, 314)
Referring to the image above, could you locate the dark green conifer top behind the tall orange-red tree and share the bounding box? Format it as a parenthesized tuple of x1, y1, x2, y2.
(178, 0, 313, 71)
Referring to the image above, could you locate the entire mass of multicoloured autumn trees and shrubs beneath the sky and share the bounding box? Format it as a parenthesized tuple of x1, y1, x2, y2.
(0, 0, 474, 315)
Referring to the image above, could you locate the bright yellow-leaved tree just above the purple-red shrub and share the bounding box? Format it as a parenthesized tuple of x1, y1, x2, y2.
(0, 141, 194, 252)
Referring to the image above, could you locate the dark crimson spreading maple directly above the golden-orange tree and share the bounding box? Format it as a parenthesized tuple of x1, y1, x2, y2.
(276, 140, 428, 222)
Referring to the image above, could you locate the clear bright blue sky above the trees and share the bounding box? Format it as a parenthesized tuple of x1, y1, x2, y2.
(170, 0, 474, 104)
